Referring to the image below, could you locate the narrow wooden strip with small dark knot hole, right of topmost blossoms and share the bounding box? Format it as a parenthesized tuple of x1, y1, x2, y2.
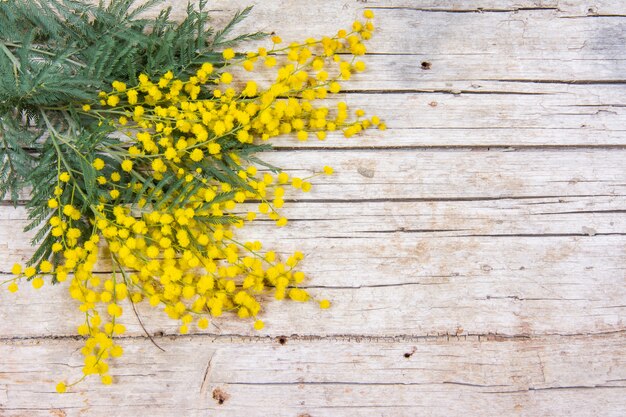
(231, 51, 624, 90)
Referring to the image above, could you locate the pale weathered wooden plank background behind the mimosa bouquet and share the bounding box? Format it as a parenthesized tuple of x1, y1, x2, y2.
(0, 0, 626, 417)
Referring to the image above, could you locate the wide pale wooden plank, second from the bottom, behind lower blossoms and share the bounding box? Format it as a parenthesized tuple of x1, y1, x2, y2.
(0, 231, 626, 337)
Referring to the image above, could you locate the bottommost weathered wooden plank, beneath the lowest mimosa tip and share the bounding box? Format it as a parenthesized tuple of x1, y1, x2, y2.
(0, 334, 626, 417)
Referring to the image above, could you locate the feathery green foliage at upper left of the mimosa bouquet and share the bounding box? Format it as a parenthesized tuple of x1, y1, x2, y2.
(0, 0, 265, 263)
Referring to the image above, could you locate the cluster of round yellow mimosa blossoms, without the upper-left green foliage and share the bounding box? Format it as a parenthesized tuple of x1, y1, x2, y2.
(3, 11, 386, 392)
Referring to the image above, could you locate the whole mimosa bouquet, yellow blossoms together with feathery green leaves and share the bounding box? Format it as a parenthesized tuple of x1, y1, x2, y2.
(0, 0, 385, 392)
